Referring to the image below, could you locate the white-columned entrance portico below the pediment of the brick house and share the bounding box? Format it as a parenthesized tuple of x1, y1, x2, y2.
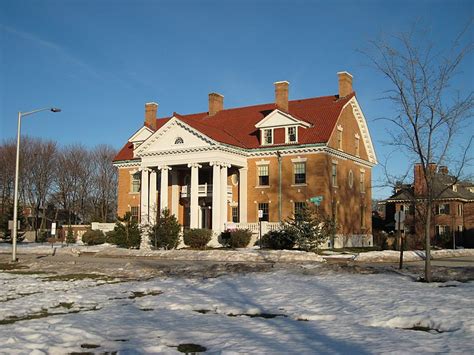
(140, 160, 247, 234)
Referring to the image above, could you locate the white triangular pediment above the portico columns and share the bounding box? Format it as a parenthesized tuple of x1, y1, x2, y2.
(135, 117, 215, 156)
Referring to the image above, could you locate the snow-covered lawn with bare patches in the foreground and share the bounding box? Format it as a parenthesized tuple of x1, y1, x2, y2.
(0, 270, 474, 354)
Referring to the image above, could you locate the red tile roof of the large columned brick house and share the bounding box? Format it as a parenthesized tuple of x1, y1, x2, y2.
(114, 93, 355, 161)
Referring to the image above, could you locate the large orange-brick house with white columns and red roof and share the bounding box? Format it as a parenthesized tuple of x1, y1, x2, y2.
(114, 72, 376, 245)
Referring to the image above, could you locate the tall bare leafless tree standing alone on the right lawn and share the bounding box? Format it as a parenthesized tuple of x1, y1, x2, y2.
(364, 26, 473, 282)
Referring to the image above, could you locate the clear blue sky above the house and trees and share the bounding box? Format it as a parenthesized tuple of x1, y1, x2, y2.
(0, 0, 474, 198)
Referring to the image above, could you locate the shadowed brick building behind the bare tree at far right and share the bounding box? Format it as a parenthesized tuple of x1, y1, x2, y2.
(385, 164, 474, 247)
